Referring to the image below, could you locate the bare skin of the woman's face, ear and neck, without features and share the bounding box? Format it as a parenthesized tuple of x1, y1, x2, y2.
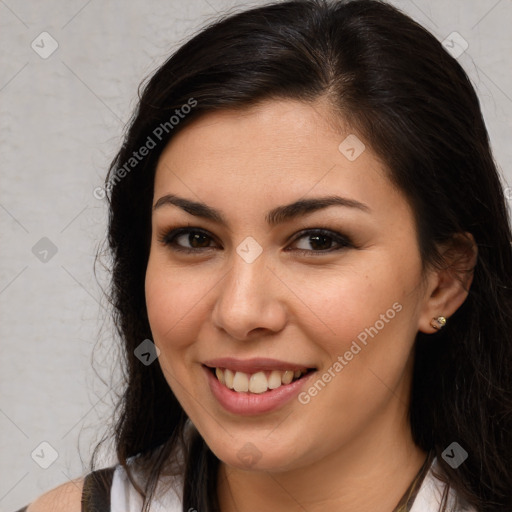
(146, 100, 476, 512)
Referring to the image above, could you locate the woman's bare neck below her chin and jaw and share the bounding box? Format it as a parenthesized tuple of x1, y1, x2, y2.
(218, 400, 427, 512)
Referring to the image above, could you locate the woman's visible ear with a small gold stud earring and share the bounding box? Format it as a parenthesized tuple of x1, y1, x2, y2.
(418, 233, 478, 334)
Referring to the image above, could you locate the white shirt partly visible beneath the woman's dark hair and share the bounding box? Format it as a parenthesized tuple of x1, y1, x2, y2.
(110, 459, 476, 512)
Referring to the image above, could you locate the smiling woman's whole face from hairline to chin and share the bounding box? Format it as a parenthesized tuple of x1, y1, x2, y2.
(146, 100, 434, 471)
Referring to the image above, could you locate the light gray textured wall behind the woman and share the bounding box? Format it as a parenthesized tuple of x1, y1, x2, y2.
(0, 0, 512, 512)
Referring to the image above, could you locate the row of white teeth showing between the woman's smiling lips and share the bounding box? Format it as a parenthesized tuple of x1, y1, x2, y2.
(207, 367, 314, 394)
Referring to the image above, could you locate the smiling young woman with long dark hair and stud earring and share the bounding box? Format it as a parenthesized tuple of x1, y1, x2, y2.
(17, 0, 512, 512)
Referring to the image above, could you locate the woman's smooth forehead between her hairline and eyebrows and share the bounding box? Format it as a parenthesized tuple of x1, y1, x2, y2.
(155, 100, 410, 224)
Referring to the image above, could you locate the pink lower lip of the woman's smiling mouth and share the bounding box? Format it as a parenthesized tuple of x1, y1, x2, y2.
(203, 366, 316, 416)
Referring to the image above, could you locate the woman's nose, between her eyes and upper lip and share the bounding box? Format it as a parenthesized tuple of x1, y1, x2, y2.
(212, 252, 286, 341)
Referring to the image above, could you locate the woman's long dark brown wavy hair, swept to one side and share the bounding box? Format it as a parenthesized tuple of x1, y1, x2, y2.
(92, 0, 512, 512)
